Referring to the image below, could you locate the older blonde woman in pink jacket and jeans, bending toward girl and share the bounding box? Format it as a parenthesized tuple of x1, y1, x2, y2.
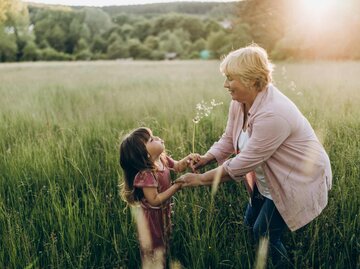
(183, 45, 332, 262)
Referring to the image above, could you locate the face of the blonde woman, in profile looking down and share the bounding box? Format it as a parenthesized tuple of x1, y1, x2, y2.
(224, 75, 257, 105)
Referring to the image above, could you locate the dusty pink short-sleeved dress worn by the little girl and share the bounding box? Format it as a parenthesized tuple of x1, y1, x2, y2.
(134, 157, 174, 255)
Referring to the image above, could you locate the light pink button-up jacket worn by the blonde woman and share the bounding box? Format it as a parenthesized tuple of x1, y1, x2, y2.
(208, 84, 332, 231)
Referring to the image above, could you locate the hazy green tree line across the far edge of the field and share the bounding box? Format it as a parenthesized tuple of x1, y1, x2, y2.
(0, 0, 360, 62)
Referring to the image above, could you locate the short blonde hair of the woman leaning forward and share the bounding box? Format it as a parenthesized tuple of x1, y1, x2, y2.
(220, 44, 274, 91)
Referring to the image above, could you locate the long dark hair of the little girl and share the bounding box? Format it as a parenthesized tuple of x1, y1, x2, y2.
(120, 127, 155, 204)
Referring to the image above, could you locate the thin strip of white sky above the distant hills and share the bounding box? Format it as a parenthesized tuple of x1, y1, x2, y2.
(23, 0, 233, 7)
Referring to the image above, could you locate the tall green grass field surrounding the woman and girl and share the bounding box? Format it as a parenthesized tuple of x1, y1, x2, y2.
(0, 61, 360, 269)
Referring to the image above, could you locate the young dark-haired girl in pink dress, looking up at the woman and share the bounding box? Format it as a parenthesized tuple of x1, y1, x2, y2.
(120, 127, 192, 268)
